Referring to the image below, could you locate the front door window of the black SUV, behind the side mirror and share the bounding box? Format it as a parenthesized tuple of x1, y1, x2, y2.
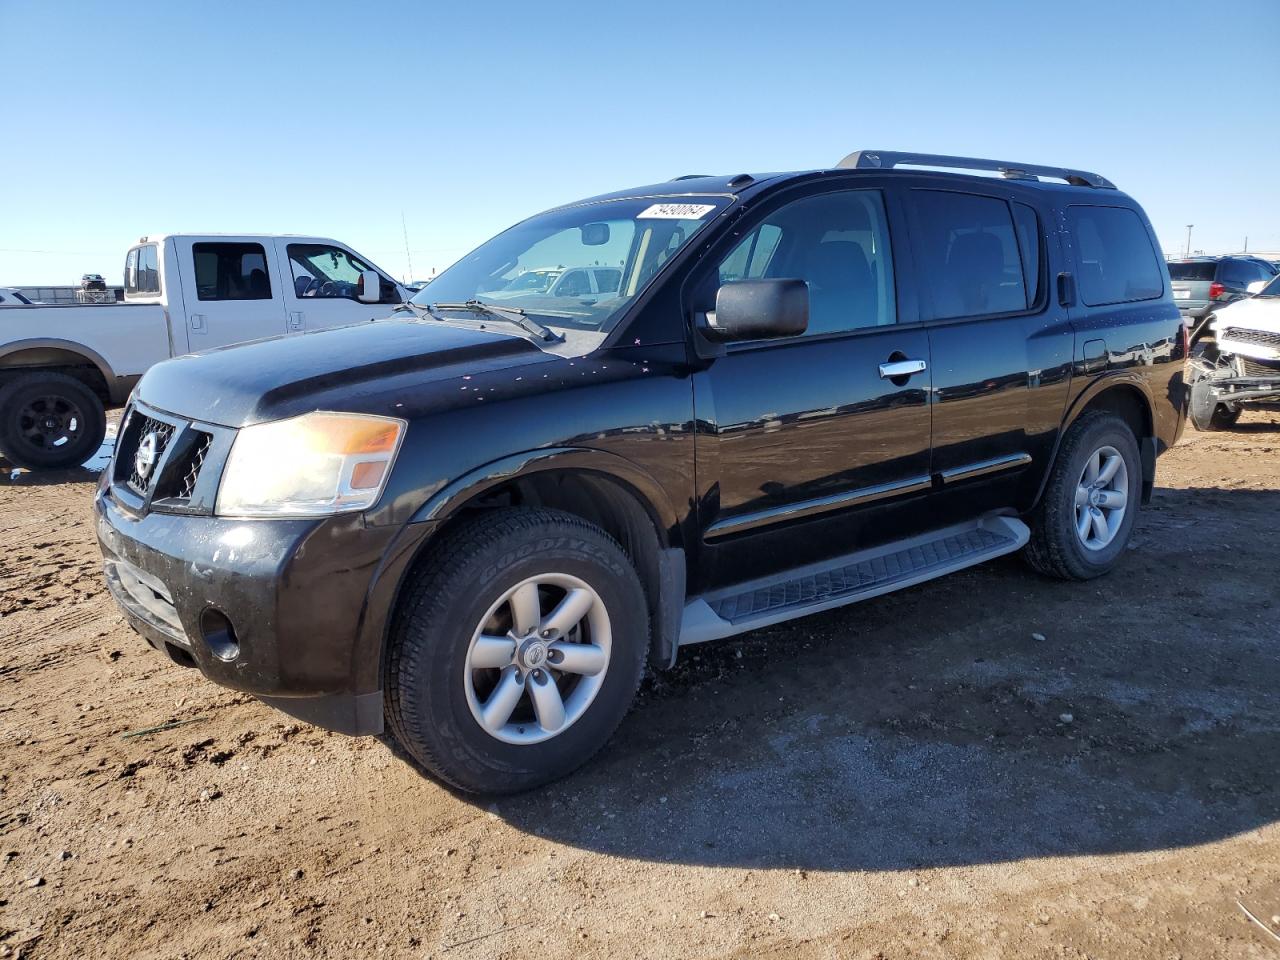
(719, 189, 897, 334)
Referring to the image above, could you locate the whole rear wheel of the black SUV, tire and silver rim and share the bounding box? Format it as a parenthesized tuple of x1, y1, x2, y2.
(1025, 411, 1142, 580)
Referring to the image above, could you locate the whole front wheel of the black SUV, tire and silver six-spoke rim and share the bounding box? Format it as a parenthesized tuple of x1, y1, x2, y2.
(385, 508, 649, 794)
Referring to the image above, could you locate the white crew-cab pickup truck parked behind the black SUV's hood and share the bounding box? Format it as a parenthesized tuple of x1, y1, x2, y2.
(0, 234, 411, 470)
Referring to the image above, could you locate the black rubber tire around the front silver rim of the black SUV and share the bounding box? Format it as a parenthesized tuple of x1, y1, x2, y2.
(384, 508, 649, 794)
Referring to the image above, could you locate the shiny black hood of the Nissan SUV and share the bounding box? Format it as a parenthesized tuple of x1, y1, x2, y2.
(136, 319, 554, 426)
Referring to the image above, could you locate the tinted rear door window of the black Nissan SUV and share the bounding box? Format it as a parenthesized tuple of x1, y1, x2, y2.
(911, 189, 1039, 320)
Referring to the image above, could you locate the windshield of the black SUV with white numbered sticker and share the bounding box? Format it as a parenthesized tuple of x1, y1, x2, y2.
(413, 197, 727, 332)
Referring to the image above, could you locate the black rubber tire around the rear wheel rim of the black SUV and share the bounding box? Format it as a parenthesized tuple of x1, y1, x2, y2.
(1023, 411, 1142, 580)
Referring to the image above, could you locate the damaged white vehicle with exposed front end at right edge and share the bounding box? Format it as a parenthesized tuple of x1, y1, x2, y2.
(1190, 276, 1280, 430)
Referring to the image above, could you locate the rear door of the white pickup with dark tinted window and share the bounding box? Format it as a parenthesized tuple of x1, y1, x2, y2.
(174, 237, 284, 352)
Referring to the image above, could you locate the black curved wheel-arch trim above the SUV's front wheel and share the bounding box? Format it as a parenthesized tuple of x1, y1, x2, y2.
(410, 447, 680, 548)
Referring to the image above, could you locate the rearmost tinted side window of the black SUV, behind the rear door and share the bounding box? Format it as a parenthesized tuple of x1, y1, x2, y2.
(1066, 206, 1165, 307)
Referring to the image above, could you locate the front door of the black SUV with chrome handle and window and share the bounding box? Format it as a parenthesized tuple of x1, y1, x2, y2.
(692, 179, 931, 589)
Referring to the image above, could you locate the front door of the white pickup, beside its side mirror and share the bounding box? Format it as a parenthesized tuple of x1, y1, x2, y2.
(275, 237, 401, 333)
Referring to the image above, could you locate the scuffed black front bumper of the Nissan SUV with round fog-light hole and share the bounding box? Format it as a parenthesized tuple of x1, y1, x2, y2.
(95, 486, 414, 733)
